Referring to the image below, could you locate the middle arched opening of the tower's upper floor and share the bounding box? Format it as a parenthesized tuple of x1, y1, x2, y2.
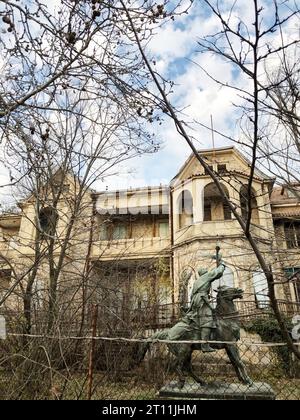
(204, 183, 231, 222)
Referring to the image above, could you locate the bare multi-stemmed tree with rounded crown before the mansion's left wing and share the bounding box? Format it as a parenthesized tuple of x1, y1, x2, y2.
(1, 92, 162, 333)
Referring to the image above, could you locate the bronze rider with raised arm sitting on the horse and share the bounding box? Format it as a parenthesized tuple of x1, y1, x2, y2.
(182, 260, 225, 353)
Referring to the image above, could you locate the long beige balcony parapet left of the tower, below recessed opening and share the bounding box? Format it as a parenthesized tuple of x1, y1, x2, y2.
(91, 238, 171, 260)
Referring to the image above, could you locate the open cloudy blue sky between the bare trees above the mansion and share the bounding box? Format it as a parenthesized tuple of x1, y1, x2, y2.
(0, 0, 299, 205)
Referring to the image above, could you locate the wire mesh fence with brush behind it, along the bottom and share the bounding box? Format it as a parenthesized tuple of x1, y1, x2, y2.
(0, 334, 300, 400)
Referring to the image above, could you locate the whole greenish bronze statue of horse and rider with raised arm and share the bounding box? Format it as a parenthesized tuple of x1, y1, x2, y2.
(138, 261, 253, 388)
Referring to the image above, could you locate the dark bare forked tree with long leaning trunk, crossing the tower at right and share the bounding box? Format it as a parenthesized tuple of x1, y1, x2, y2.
(122, 0, 300, 359)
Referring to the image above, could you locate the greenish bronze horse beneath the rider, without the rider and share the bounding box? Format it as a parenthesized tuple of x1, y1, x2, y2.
(138, 286, 253, 388)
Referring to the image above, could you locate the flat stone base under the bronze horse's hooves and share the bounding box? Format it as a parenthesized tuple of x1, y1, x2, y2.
(159, 381, 276, 400)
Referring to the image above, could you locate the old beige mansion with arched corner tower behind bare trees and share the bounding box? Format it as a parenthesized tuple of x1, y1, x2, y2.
(0, 147, 300, 332)
